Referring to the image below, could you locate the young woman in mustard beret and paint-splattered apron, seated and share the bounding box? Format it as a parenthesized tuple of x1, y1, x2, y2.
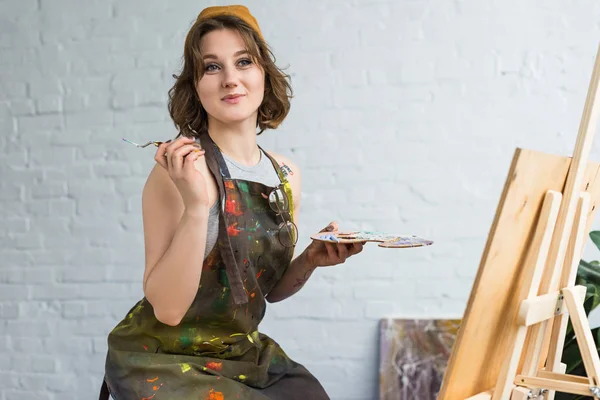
(103, 6, 362, 400)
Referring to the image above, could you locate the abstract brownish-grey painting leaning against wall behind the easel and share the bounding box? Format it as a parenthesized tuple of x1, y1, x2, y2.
(379, 319, 460, 400)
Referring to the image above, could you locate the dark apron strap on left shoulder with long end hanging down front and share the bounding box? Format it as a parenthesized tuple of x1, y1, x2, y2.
(200, 132, 248, 304)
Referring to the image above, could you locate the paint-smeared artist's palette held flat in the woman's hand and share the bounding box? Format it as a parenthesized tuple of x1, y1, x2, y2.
(310, 231, 433, 248)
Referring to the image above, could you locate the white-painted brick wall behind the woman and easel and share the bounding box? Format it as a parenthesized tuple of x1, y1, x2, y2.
(0, 0, 600, 400)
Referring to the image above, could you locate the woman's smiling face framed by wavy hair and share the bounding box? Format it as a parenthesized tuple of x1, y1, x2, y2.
(196, 29, 265, 124)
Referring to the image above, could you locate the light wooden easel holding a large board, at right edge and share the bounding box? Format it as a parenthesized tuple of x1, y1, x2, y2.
(438, 42, 600, 400)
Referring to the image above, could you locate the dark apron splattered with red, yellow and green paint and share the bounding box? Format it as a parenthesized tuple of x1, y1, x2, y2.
(105, 134, 329, 400)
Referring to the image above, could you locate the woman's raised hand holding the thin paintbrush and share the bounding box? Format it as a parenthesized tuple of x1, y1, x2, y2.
(154, 136, 209, 212)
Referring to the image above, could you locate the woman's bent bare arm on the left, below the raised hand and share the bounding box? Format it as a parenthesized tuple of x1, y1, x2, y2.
(142, 139, 217, 326)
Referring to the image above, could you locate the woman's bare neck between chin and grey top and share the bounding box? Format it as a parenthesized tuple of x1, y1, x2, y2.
(208, 116, 260, 166)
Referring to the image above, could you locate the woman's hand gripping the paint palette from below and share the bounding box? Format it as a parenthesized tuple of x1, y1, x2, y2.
(306, 222, 364, 267)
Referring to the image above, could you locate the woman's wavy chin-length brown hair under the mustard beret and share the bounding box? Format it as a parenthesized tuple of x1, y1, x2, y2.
(169, 15, 292, 137)
